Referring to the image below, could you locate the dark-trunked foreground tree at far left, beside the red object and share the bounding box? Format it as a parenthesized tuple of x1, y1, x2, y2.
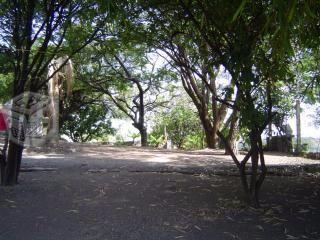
(0, 0, 112, 185)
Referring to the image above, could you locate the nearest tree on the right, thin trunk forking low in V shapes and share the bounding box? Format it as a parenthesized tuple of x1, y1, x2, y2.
(179, 0, 302, 206)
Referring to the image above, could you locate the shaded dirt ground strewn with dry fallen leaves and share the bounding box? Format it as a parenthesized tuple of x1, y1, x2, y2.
(0, 143, 320, 240)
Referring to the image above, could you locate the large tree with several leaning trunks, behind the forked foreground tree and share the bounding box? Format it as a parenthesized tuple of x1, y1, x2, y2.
(133, 1, 238, 148)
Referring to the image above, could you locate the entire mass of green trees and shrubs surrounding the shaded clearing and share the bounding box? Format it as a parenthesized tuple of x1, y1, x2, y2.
(0, 0, 320, 206)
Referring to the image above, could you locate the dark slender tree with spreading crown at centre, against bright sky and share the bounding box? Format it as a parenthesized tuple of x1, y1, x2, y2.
(81, 41, 176, 146)
